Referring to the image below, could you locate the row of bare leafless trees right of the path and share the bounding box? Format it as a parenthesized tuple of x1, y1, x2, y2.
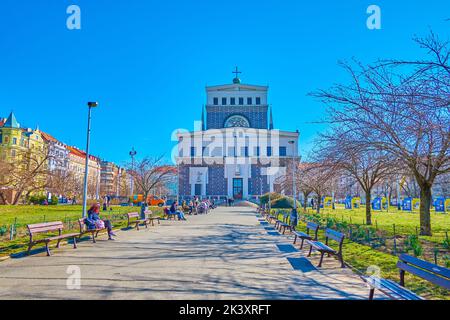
(286, 33, 450, 235)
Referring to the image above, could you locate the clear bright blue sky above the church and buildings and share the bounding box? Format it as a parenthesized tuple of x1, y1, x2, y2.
(0, 0, 450, 164)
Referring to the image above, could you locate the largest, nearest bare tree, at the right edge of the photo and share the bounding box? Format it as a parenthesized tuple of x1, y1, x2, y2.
(314, 34, 450, 235)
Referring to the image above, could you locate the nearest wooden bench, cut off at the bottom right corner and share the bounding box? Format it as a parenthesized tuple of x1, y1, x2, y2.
(364, 254, 450, 300)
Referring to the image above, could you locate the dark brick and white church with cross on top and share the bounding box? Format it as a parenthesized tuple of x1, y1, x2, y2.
(176, 68, 299, 199)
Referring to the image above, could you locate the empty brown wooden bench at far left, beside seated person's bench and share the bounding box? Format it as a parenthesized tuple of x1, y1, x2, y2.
(27, 221, 79, 256)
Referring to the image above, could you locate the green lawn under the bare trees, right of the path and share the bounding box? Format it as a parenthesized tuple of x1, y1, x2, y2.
(272, 206, 450, 300)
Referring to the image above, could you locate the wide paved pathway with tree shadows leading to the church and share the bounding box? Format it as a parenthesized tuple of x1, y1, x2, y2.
(0, 207, 380, 300)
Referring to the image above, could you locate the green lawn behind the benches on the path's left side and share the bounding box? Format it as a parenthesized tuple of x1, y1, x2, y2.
(0, 205, 162, 256)
